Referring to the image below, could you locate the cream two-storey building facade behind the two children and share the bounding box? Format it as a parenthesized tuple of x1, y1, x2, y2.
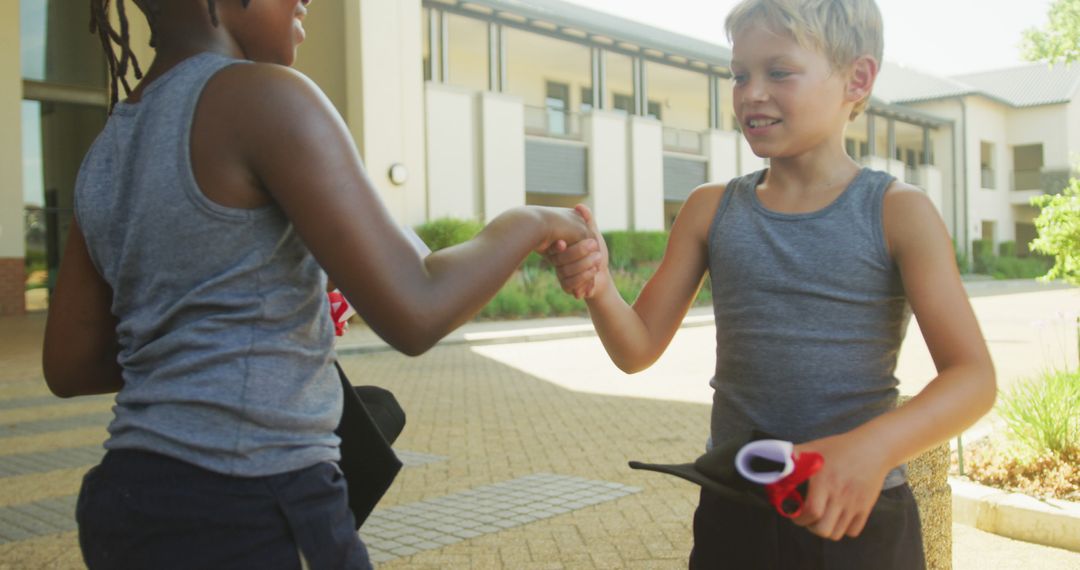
(12, 0, 1078, 313)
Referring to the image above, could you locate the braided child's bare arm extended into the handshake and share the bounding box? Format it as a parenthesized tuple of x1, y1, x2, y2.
(219, 65, 589, 354)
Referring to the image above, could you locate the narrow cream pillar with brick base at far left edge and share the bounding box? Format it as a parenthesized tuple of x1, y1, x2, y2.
(0, 2, 26, 315)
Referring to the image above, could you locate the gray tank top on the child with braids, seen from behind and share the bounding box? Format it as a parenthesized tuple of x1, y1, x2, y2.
(76, 53, 341, 476)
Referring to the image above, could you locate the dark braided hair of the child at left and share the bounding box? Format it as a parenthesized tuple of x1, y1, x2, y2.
(90, 0, 251, 113)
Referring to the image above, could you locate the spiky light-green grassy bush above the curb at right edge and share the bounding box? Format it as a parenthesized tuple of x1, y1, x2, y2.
(997, 371, 1080, 458)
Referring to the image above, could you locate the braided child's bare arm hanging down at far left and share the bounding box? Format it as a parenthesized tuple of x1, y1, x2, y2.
(42, 221, 124, 397)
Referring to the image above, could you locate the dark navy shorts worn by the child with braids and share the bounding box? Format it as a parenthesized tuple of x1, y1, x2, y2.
(76, 450, 372, 570)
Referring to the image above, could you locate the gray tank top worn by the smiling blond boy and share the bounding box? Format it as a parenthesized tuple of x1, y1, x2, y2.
(708, 168, 910, 488)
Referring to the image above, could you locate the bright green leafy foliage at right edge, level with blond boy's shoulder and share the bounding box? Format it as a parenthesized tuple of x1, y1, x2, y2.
(1031, 178, 1080, 285)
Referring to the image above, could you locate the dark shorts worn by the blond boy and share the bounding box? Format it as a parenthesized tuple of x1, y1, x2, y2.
(690, 484, 926, 570)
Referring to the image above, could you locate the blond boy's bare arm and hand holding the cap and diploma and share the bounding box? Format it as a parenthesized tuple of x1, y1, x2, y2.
(796, 185, 996, 540)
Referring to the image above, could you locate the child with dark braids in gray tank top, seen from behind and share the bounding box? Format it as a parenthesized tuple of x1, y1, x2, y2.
(42, 0, 597, 570)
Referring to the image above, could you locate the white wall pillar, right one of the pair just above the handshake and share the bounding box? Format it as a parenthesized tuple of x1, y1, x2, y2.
(627, 117, 664, 231)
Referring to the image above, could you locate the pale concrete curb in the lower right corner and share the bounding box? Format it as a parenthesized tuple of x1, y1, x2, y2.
(948, 477, 1080, 553)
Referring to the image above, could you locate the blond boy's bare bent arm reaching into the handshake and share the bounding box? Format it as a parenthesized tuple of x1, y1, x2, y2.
(561, 185, 724, 374)
